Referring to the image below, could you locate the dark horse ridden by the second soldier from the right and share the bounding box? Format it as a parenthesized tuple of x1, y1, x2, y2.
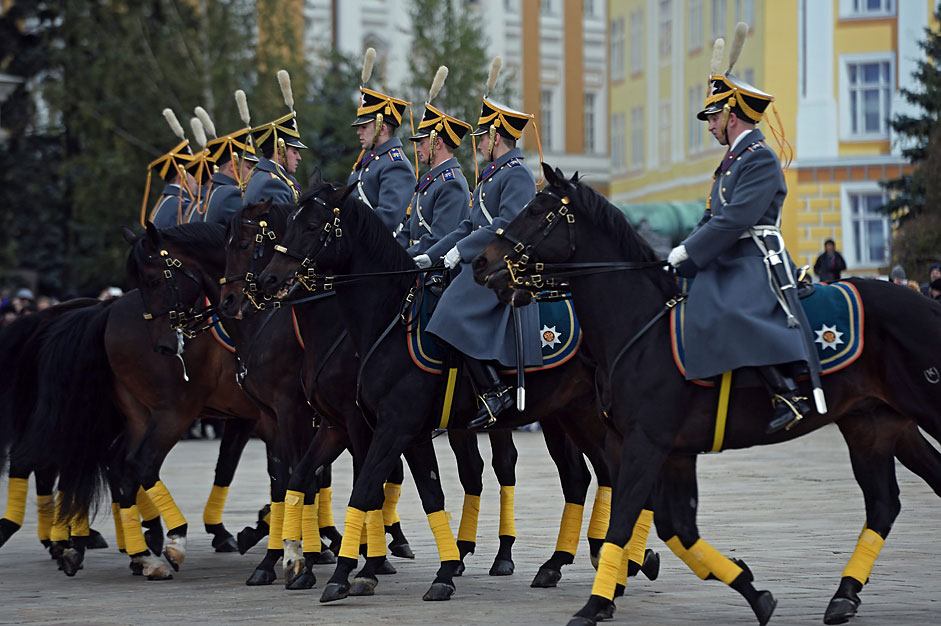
(259, 180, 646, 601)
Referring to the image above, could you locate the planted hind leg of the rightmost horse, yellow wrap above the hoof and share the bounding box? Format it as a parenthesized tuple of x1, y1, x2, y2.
(823, 406, 907, 624)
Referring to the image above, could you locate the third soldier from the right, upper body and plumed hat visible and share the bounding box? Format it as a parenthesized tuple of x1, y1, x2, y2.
(396, 65, 471, 256)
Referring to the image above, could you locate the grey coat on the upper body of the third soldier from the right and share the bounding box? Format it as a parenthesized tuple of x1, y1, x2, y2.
(396, 157, 470, 256)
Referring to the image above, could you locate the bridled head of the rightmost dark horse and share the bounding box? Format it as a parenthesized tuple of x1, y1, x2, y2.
(471, 163, 578, 306)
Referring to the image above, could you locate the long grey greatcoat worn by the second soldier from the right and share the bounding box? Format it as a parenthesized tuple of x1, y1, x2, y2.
(425, 148, 542, 367)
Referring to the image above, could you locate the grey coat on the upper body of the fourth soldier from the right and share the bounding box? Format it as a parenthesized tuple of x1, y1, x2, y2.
(347, 137, 415, 233)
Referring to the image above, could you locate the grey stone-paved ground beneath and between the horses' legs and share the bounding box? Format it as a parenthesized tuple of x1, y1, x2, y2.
(0, 427, 941, 626)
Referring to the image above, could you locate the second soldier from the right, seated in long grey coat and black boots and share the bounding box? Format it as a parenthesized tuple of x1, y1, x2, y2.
(425, 57, 542, 428)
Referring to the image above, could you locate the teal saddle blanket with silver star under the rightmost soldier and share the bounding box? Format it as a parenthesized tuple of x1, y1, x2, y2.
(670, 282, 864, 385)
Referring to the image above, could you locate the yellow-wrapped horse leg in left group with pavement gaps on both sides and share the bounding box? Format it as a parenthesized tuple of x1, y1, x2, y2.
(203, 419, 255, 552)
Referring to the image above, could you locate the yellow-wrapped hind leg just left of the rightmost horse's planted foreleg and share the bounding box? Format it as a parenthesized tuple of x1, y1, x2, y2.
(530, 419, 591, 587)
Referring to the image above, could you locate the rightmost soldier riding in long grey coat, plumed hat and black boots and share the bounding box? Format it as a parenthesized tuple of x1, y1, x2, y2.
(668, 23, 816, 433)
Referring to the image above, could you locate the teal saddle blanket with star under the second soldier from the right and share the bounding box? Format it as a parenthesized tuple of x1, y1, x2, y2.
(406, 289, 582, 374)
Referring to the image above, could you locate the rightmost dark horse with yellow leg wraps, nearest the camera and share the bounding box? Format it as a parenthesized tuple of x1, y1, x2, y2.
(472, 165, 941, 625)
